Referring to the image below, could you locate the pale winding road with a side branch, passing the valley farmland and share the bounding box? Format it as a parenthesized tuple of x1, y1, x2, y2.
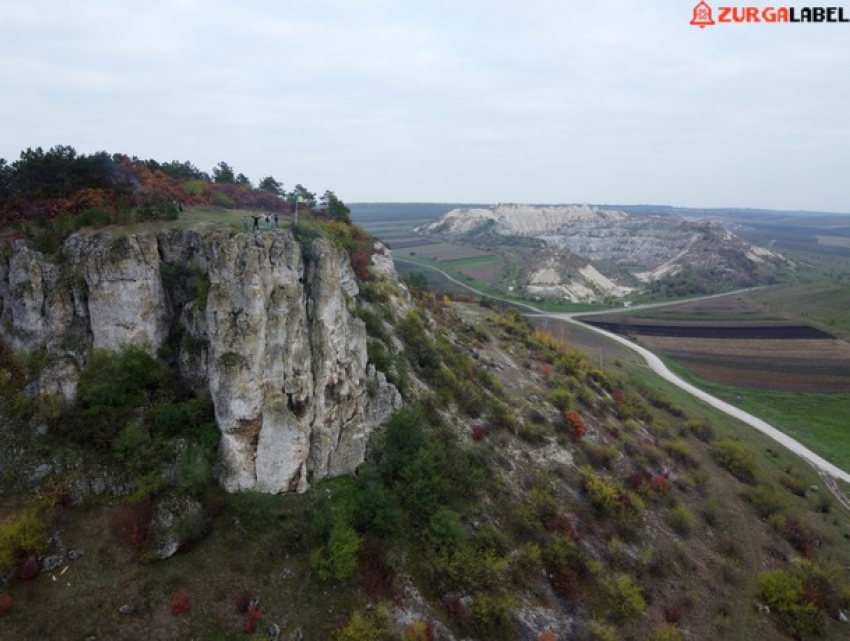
(396, 256, 850, 496)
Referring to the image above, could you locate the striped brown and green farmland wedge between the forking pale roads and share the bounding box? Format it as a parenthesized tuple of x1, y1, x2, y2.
(584, 284, 850, 469)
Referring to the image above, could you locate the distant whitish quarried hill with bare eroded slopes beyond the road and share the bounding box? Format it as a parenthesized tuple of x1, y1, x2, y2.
(417, 205, 788, 302)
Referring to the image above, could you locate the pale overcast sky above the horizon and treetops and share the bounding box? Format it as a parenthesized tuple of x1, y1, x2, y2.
(0, 0, 850, 213)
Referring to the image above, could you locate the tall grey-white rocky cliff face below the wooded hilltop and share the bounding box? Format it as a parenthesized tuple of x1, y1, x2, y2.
(0, 231, 401, 492)
